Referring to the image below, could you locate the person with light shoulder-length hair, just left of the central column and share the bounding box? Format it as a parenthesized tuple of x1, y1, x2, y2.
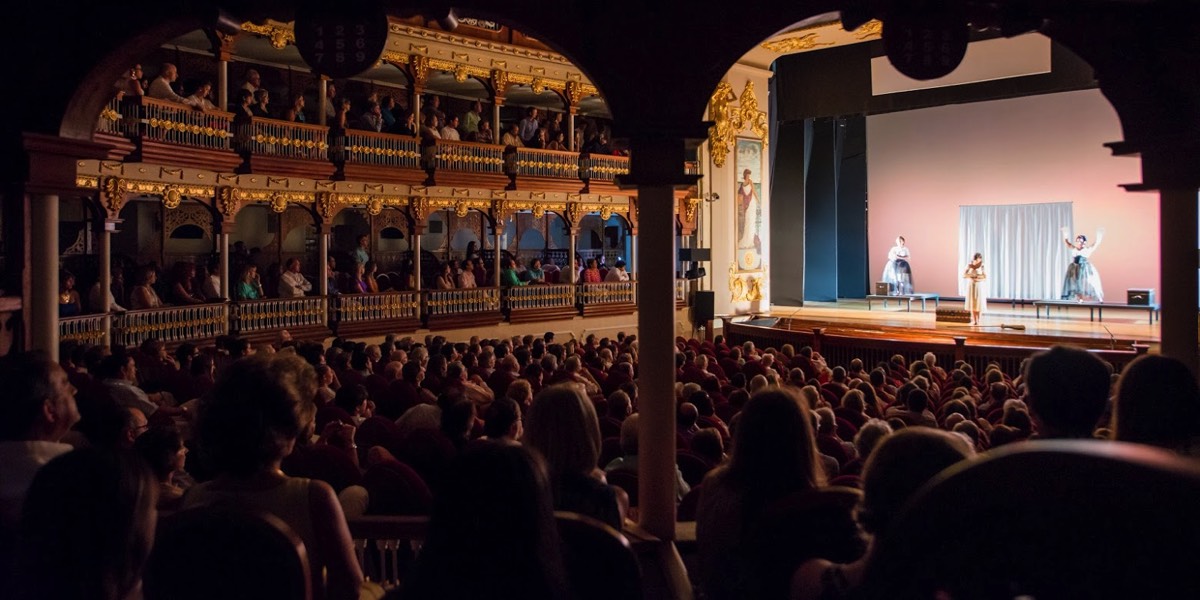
(524, 384, 623, 530)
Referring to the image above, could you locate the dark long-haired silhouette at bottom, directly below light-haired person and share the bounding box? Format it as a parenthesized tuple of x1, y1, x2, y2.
(403, 443, 574, 600)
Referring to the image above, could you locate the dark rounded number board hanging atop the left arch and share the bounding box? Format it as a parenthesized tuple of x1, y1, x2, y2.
(295, 0, 388, 79)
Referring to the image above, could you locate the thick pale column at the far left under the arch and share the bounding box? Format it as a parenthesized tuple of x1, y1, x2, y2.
(29, 194, 59, 361)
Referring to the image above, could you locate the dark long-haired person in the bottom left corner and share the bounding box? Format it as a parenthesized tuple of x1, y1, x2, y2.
(13, 449, 158, 600)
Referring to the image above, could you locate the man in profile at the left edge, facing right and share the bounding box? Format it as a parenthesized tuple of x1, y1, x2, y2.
(0, 354, 79, 532)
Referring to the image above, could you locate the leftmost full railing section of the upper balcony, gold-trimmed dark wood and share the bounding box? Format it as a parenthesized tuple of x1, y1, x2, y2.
(121, 96, 233, 150)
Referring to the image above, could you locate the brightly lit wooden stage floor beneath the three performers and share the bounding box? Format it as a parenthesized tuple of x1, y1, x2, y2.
(764, 300, 1160, 352)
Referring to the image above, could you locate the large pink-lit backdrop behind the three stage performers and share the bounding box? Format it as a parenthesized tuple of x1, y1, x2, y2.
(866, 90, 1159, 302)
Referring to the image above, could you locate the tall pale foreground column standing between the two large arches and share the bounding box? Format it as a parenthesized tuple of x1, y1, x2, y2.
(637, 182, 682, 540)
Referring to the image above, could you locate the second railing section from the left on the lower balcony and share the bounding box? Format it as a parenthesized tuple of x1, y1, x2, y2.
(113, 304, 229, 346)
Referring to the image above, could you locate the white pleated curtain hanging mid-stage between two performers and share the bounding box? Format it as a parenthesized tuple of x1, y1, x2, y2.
(959, 202, 1075, 300)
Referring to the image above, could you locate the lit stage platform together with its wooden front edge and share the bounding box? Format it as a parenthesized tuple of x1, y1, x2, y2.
(739, 300, 1160, 352)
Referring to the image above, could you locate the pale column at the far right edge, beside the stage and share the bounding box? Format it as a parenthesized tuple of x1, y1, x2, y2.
(1158, 188, 1200, 372)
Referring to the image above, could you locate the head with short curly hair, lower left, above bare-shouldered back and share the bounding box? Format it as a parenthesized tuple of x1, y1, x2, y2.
(197, 354, 317, 476)
